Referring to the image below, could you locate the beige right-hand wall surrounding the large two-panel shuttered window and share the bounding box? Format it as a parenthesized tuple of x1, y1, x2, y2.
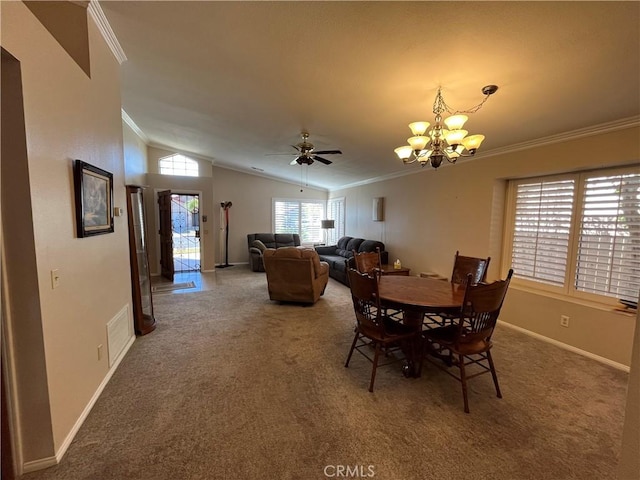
(330, 128, 640, 365)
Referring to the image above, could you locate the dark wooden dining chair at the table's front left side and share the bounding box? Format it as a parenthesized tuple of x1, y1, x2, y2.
(344, 268, 420, 392)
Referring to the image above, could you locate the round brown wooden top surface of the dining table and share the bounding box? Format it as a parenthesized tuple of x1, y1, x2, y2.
(378, 275, 465, 312)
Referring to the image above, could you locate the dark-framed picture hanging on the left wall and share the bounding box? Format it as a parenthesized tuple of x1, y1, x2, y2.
(73, 160, 113, 238)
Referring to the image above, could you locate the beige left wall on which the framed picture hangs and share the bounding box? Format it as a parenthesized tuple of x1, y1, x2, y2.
(1, 2, 133, 463)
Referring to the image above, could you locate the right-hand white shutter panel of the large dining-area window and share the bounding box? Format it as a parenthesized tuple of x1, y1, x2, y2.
(575, 174, 640, 301)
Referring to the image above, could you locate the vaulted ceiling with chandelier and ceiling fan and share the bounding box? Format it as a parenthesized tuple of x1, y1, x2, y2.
(100, 0, 640, 190)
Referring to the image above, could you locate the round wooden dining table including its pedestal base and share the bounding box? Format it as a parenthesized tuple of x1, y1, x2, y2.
(378, 275, 465, 377)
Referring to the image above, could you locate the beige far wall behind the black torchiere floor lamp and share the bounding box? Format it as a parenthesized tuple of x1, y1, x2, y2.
(213, 166, 328, 264)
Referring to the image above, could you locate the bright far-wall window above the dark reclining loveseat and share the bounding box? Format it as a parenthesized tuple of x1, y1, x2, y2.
(273, 199, 324, 244)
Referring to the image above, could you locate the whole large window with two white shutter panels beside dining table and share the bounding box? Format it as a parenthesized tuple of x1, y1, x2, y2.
(507, 169, 640, 300)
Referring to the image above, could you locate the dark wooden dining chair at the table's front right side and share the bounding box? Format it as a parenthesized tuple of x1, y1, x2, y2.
(420, 270, 513, 413)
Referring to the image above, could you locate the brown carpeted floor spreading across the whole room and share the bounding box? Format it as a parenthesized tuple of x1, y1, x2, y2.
(25, 267, 628, 480)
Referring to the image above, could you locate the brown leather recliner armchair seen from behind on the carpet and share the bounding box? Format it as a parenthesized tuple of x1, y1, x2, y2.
(263, 247, 329, 303)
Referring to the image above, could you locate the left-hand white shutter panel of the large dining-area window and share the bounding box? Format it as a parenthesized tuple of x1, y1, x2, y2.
(512, 180, 575, 286)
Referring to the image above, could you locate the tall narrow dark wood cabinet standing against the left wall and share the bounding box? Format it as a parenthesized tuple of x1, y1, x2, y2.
(127, 185, 156, 335)
